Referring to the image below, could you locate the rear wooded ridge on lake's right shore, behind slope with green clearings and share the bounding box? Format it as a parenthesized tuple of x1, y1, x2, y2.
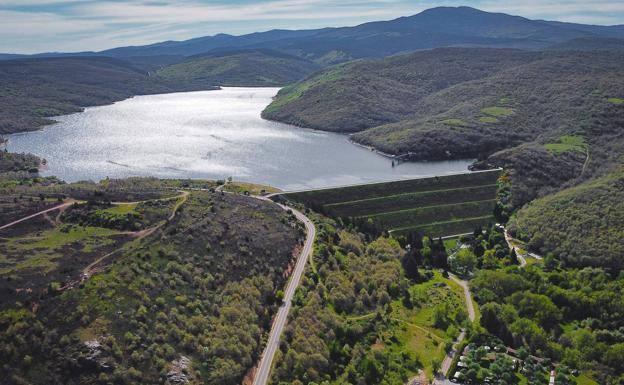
(263, 49, 538, 132)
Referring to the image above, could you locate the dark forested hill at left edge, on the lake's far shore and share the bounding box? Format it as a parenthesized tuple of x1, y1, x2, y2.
(0, 57, 212, 134)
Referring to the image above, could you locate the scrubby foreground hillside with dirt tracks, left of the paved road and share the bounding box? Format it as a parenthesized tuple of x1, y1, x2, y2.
(0, 178, 303, 385)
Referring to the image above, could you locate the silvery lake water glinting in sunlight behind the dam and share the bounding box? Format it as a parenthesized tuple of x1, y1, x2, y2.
(8, 88, 471, 190)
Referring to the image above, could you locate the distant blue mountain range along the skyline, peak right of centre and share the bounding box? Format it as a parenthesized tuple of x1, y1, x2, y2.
(88, 7, 624, 64)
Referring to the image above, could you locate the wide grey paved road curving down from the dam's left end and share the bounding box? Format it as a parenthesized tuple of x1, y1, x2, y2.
(253, 197, 316, 385)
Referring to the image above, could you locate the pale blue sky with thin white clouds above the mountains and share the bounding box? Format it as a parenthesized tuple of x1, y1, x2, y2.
(0, 0, 624, 53)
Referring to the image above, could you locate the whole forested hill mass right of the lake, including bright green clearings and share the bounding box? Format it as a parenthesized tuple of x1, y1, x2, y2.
(263, 48, 624, 206)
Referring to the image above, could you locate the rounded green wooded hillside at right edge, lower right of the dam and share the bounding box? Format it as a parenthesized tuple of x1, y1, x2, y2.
(509, 167, 624, 271)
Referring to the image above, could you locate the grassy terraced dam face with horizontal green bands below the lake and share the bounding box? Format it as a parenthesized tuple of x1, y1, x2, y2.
(277, 170, 501, 237)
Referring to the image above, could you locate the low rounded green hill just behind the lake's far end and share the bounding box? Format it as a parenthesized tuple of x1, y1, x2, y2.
(156, 49, 320, 87)
